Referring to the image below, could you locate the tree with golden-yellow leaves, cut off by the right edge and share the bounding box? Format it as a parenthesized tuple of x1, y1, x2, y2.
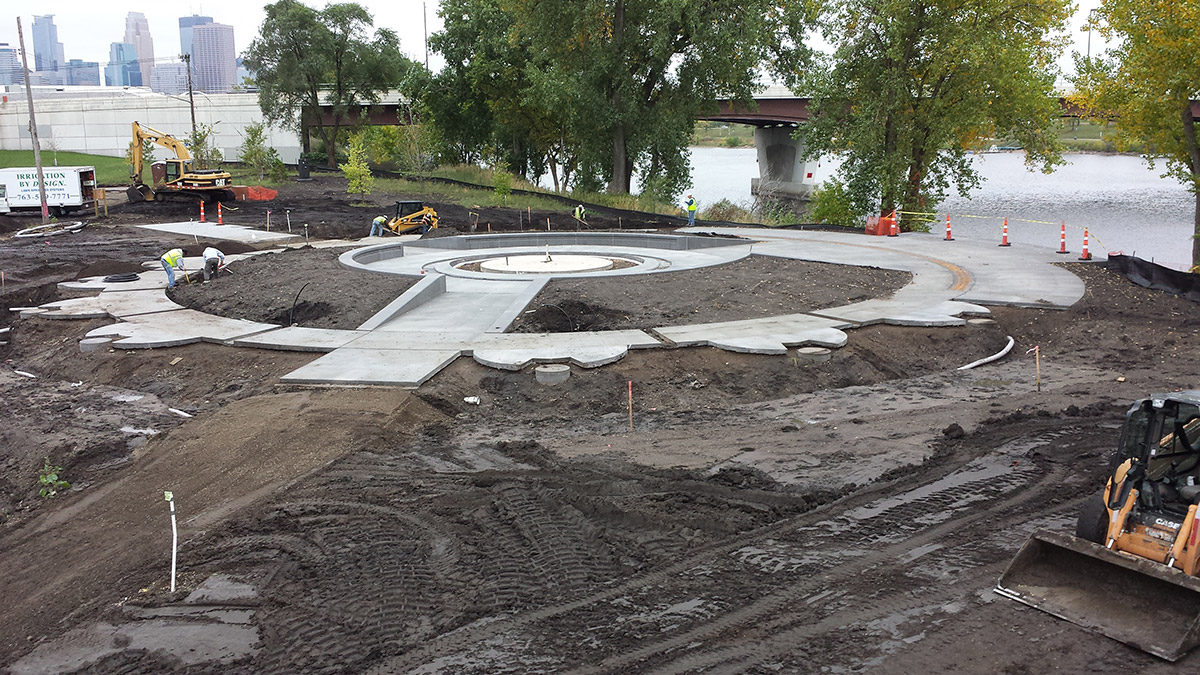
(1072, 0, 1200, 271)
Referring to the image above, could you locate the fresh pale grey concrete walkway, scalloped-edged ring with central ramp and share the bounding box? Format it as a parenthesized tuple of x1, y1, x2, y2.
(41, 223, 1084, 387)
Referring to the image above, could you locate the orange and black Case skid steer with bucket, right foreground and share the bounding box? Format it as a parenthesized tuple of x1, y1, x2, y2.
(996, 392, 1200, 661)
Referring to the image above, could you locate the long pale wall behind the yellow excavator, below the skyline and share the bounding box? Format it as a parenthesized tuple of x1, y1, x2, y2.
(0, 85, 300, 163)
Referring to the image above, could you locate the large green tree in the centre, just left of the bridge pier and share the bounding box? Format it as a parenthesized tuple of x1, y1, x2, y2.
(500, 0, 815, 193)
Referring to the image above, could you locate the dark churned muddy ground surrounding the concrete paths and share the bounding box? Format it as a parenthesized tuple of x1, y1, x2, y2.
(0, 177, 1200, 673)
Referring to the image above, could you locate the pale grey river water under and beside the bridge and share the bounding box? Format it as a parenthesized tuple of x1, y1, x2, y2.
(691, 148, 1195, 269)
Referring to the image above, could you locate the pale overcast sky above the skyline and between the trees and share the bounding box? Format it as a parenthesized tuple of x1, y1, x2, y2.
(0, 0, 1103, 82)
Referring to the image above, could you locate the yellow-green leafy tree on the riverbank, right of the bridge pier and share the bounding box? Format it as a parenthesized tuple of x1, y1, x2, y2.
(803, 0, 1072, 225)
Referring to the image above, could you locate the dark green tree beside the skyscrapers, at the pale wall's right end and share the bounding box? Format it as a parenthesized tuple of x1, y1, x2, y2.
(245, 0, 418, 168)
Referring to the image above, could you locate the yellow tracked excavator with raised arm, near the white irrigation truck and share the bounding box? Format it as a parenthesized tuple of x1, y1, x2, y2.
(128, 123, 235, 202)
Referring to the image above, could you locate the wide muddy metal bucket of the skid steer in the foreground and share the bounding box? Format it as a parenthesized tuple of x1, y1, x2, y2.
(996, 532, 1200, 661)
